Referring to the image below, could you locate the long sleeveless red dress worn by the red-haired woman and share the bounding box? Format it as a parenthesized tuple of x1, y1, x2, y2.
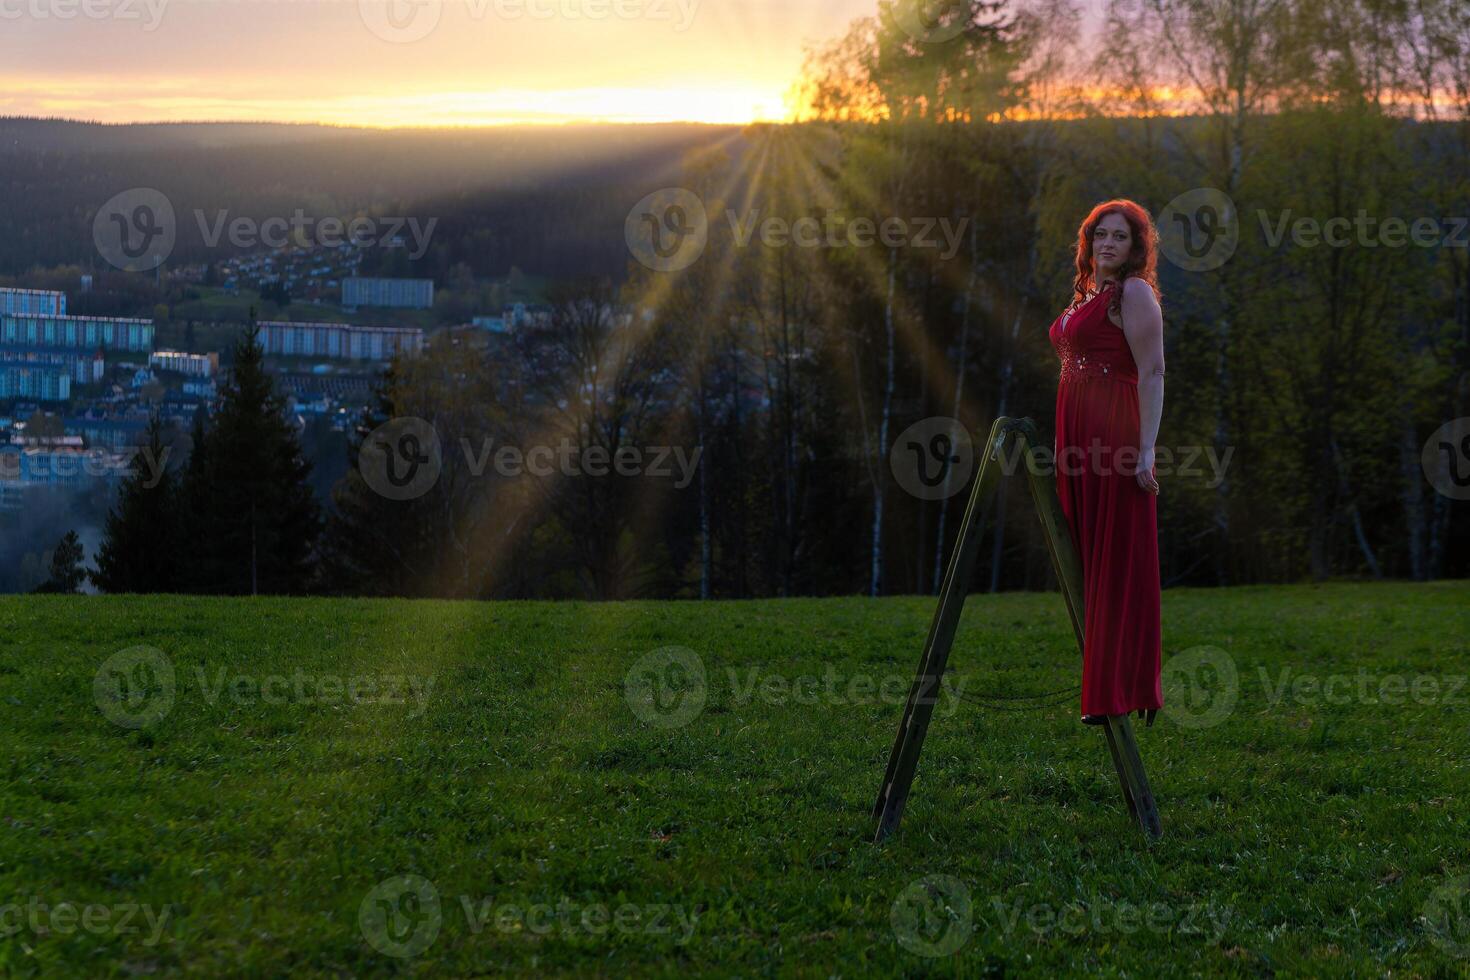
(1048, 284, 1164, 716)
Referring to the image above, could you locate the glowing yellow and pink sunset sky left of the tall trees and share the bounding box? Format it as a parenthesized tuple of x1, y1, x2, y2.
(0, 0, 1105, 126)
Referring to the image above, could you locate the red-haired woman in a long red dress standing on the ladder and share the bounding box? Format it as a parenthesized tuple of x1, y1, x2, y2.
(1050, 200, 1164, 724)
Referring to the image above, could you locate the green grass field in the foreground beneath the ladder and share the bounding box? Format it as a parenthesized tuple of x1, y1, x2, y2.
(0, 582, 1470, 977)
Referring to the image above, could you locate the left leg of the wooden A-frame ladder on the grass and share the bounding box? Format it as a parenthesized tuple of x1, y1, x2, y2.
(873, 416, 1010, 843)
